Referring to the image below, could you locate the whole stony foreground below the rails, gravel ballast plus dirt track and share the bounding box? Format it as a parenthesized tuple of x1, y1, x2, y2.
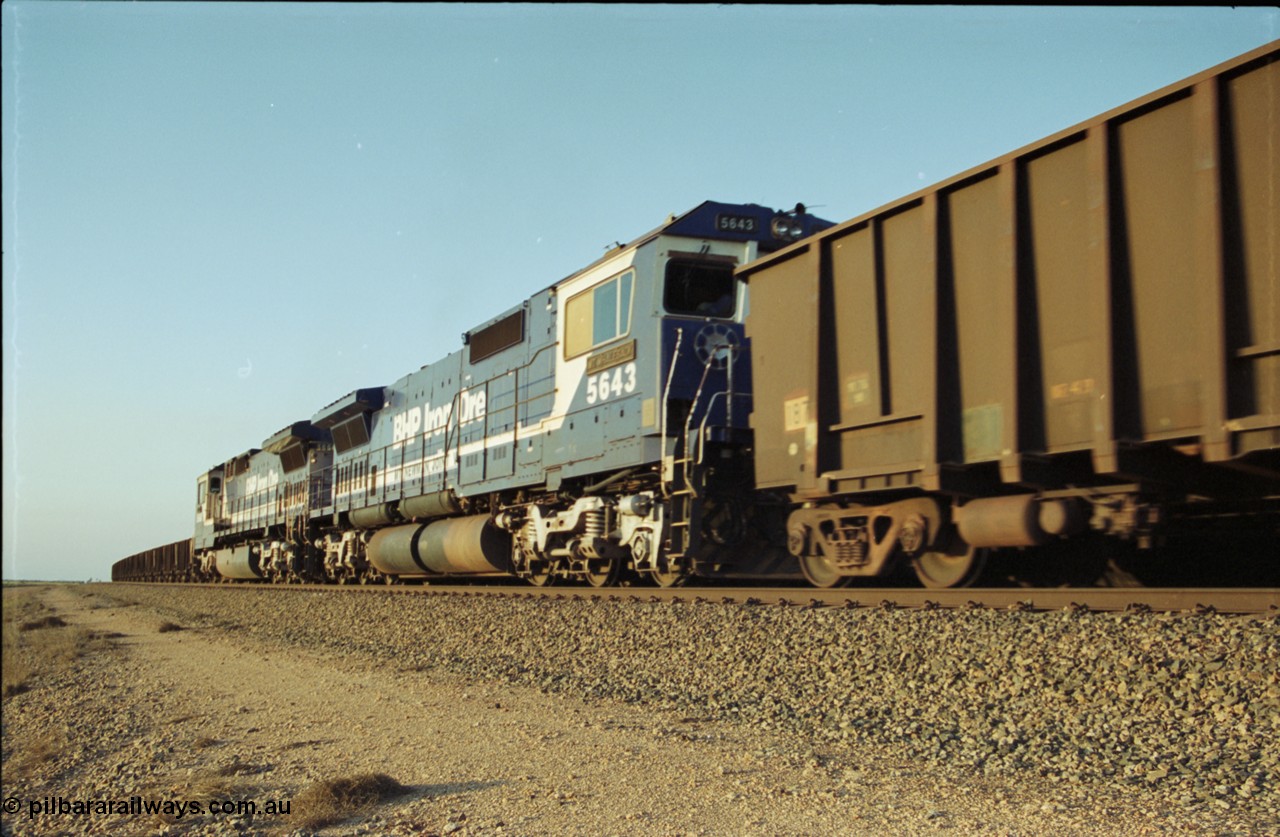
(5, 585, 1280, 834)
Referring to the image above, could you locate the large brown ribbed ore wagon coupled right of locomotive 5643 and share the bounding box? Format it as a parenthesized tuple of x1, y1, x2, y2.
(740, 42, 1280, 586)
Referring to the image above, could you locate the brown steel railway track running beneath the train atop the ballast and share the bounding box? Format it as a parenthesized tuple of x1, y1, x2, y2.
(116, 582, 1280, 616)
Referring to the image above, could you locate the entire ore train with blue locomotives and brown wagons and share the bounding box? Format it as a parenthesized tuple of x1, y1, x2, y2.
(111, 42, 1280, 587)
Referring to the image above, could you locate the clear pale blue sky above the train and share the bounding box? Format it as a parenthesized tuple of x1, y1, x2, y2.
(0, 0, 1280, 578)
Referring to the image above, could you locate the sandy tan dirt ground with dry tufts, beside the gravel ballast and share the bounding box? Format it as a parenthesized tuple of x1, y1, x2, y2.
(3, 585, 1259, 834)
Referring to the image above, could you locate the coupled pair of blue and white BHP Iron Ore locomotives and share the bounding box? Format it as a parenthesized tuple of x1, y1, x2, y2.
(186, 202, 832, 586)
